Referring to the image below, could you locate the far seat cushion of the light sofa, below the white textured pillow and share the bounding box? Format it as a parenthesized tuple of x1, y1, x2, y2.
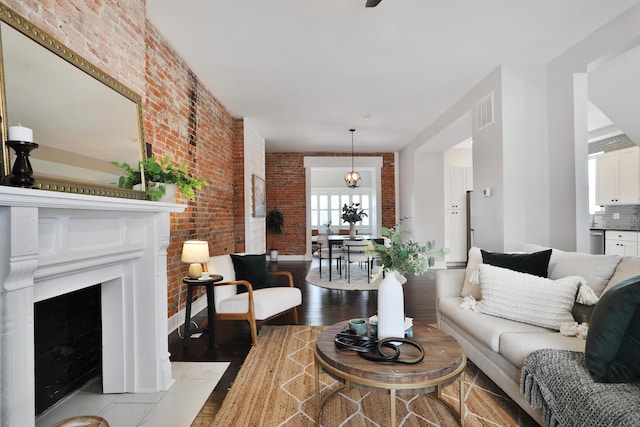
(438, 297, 549, 352)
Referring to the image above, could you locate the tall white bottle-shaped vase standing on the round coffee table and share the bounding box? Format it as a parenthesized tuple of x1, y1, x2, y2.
(378, 271, 404, 339)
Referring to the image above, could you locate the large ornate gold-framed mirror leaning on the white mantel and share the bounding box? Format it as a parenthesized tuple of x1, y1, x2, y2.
(0, 3, 147, 199)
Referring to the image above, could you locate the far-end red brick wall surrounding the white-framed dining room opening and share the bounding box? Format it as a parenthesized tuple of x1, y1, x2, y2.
(265, 153, 396, 255)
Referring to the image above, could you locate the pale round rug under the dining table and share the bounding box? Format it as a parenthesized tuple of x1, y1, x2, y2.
(305, 265, 407, 291)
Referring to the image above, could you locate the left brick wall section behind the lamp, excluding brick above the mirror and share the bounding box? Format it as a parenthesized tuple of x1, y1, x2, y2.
(144, 25, 235, 316)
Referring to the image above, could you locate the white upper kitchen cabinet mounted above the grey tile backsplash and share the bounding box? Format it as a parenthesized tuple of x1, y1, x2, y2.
(596, 147, 640, 206)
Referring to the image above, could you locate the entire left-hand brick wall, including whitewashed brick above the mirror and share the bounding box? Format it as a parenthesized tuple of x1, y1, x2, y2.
(5, 0, 236, 316)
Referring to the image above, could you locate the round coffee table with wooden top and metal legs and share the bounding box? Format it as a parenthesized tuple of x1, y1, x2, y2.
(314, 321, 467, 427)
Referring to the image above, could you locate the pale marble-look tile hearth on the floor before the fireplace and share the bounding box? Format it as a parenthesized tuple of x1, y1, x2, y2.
(36, 362, 229, 427)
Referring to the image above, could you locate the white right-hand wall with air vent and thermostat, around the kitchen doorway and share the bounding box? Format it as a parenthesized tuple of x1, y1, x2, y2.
(399, 69, 503, 250)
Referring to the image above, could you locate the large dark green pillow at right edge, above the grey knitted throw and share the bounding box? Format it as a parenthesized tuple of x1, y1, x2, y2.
(585, 276, 640, 383)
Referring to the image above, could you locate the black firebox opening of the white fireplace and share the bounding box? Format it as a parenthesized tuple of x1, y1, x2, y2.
(34, 284, 102, 415)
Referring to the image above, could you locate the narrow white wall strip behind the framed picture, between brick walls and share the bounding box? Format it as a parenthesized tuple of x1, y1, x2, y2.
(244, 118, 267, 254)
